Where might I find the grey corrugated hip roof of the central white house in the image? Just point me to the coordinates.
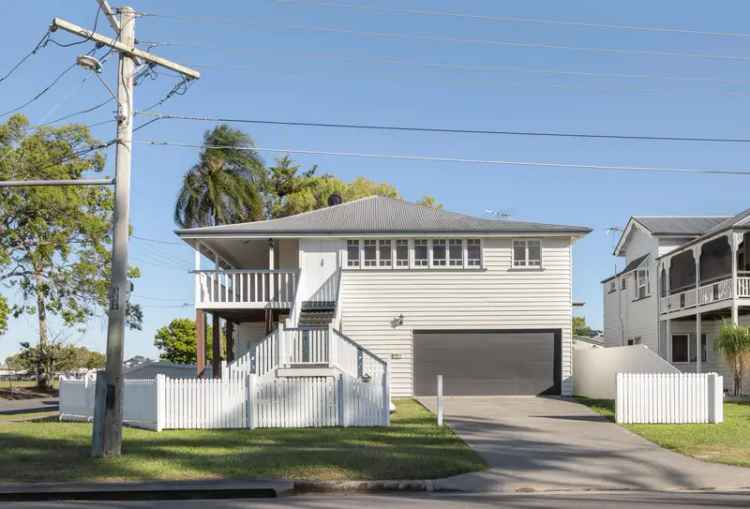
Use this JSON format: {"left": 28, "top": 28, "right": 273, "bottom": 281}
{"left": 176, "top": 196, "right": 591, "bottom": 236}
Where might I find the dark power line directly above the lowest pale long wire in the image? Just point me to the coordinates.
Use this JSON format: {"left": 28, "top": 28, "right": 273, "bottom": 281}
{"left": 136, "top": 111, "right": 750, "bottom": 143}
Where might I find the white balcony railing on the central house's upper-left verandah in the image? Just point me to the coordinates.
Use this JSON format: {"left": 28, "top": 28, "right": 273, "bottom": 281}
{"left": 195, "top": 270, "right": 299, "bottom": 308}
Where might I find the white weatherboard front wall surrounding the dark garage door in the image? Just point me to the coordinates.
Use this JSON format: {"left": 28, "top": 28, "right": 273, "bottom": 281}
{"left": 341, "top": 237, "right": 573, "bottom": 396}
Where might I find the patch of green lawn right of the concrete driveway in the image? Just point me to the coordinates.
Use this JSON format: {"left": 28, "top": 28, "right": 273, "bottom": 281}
{"left": 576, "top": 398, "right": 750, "bottom": 467}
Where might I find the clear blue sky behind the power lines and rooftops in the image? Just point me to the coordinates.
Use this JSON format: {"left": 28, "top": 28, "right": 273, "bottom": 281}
{"left": 0, "top": 0, "right": 750, "bottom": 359}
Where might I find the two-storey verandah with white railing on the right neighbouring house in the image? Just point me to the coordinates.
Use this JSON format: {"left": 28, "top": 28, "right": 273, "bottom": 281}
{"left": 657, "top": 228, "right": 750, "bottom": 372}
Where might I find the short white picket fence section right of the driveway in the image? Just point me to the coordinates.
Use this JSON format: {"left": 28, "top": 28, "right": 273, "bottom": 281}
{"left": 615, "top": 373, "right": 724, "bottom": 424}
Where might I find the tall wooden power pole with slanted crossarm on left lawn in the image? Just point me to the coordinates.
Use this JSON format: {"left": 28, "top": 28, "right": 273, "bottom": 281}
{"left": 51, "top": 4, "right": 200, "bottom": 456}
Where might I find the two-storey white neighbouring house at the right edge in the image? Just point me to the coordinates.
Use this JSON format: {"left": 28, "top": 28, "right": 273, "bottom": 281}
{"left": 602, "top": 209, "right": 750, "bottom": 388}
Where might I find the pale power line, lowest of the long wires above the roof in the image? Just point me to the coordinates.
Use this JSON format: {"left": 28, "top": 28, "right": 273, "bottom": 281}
{"left": 134, "top": 140, "right": 750, "bottom": 177}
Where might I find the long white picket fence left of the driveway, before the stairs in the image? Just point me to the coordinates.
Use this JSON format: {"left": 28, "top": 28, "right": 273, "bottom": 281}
{"left": 60, "top": 370, "right": 390, "bottom": 431}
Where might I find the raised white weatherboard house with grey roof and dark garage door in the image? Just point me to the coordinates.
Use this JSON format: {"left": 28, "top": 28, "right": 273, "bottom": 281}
{"left": 177, "top": 197, "right": 590, "bottom": 396}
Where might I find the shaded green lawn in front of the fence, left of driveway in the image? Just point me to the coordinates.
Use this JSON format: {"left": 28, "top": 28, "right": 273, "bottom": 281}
{"left": 0, "top": 400, "right": 486, "bottom": 482}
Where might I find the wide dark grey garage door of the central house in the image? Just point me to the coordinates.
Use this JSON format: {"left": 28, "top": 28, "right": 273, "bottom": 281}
{"left": 414, "top": 330, "right": 560, "bottom": 396}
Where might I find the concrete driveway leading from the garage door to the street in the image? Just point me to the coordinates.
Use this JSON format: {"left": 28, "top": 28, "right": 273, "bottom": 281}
{"left": 419, "top": 397, "right": 750, "bottom": 492}
